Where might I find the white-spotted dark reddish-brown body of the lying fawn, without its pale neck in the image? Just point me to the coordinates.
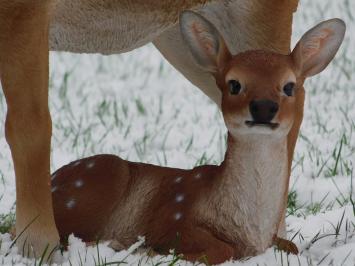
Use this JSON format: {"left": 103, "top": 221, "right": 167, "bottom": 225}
{"left": 52, "top": 149, "right": 286, "bottom": 264}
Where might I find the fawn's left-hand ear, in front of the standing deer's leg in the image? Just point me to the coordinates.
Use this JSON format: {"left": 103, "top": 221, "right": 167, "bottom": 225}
{"left": 180, "top": 11, "right": 231, "bottom": 74}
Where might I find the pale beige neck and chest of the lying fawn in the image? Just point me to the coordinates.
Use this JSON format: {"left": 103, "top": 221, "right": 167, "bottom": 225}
{"left": 206, "top": 135, "right": 288, "bottom": 249}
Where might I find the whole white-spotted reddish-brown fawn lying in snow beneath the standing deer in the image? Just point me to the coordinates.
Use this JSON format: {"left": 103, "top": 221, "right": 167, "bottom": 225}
{"left": 52, "top": 11, "right": 345, "bottom": 263}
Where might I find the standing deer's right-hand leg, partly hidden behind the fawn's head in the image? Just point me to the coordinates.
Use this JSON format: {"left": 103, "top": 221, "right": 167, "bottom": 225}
{"left": 154, "top": 0, "right": 304, "bottom": 240}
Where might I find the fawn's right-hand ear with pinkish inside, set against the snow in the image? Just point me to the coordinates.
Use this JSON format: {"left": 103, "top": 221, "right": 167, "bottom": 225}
{"left": 291, "top": 19, "right": 346, "bottom": 77}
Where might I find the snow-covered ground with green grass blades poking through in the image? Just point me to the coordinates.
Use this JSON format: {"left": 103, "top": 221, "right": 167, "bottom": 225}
{"left": 0, "top": 0, "right": 355, "bottom": 266}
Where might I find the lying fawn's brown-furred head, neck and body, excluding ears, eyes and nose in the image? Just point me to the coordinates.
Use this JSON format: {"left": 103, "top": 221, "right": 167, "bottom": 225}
{"left": 52, "top": 48, "right": 303, "bottom": 263}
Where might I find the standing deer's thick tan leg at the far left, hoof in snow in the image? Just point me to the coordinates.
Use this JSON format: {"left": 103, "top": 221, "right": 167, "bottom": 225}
{"left": 0, "top": 0, "right": 59, "bottom": 256}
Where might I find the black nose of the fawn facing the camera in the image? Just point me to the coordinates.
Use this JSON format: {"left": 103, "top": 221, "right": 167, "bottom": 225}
{"left": 249, "top": 100, "right": 279, "bottom": 123}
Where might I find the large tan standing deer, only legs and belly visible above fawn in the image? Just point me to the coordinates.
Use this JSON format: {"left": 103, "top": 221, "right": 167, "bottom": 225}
{"left": 0, "top": 0, "right": 304, "bottom": 255}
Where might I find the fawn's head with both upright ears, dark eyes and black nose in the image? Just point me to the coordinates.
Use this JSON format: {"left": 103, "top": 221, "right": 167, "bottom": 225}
{"left": 180, "top": 11, "right": 345, "bottom": 136}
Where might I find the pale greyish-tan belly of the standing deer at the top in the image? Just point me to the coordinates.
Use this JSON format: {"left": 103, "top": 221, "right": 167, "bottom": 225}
{"left": 49, "top": 0, "right": 212, "bottom": 54}
